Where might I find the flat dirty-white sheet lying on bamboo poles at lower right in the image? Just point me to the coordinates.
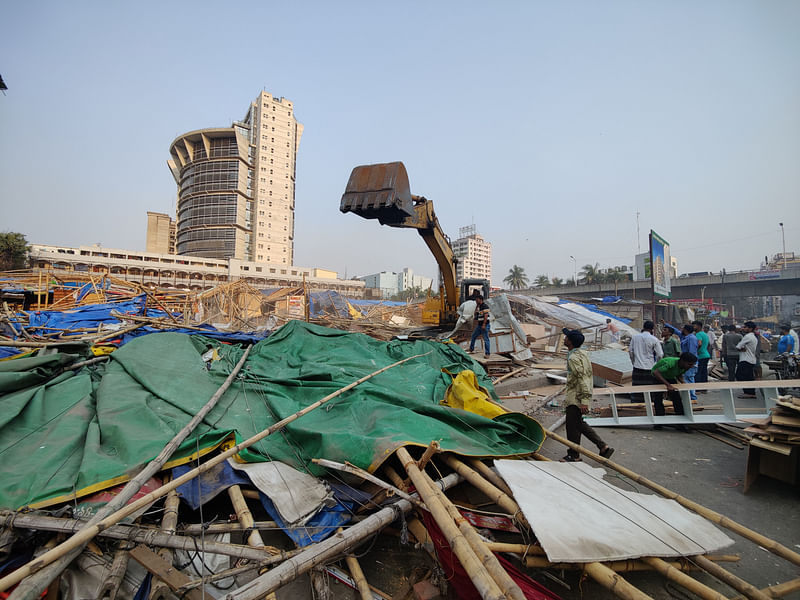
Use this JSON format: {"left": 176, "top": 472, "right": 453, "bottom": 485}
{"left": 494, "top": 460, "right": 733, "bottom": 562}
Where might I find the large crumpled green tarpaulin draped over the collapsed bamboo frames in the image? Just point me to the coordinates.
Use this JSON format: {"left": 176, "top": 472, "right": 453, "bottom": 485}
{"left": 0, "top": 321, "right": 544, "bottom": 509}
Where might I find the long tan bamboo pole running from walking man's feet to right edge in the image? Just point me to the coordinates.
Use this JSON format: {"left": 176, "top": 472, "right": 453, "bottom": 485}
{"left": 547, "top": 432, "right": 800, "bottom": 566}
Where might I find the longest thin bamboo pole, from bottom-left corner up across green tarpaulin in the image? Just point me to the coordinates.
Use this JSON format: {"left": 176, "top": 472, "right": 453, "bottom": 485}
{"left": 0, "top": 349, "right": 430, "bottom": 600}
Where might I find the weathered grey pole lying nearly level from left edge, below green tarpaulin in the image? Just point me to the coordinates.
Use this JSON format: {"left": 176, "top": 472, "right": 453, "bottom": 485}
{"left": 0, "top": 512, "right": 297, "bottom": 564}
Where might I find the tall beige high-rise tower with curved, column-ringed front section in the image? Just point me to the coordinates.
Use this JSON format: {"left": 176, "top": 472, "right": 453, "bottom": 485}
{"left": 167, "top": 92, "right": 303, "bottom": 265}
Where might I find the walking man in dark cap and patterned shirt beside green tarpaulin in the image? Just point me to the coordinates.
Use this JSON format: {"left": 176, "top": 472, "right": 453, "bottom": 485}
{"left": 561, "top": 328, "right": 614, "bottom": 462}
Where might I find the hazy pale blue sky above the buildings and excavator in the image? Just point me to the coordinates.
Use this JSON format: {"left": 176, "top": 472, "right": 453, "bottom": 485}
{"left": 0, "top": 0, "right": 800, "bottom": 285}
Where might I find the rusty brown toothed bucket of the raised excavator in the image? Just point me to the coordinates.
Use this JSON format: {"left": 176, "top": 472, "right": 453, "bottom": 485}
{"left": 339, "top": 162, "right": 414, "bottom": 226}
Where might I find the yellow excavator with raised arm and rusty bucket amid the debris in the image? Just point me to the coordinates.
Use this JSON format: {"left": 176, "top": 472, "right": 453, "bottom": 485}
{"left": 339, "top": 162, "right": 489, "bottom": 327}
